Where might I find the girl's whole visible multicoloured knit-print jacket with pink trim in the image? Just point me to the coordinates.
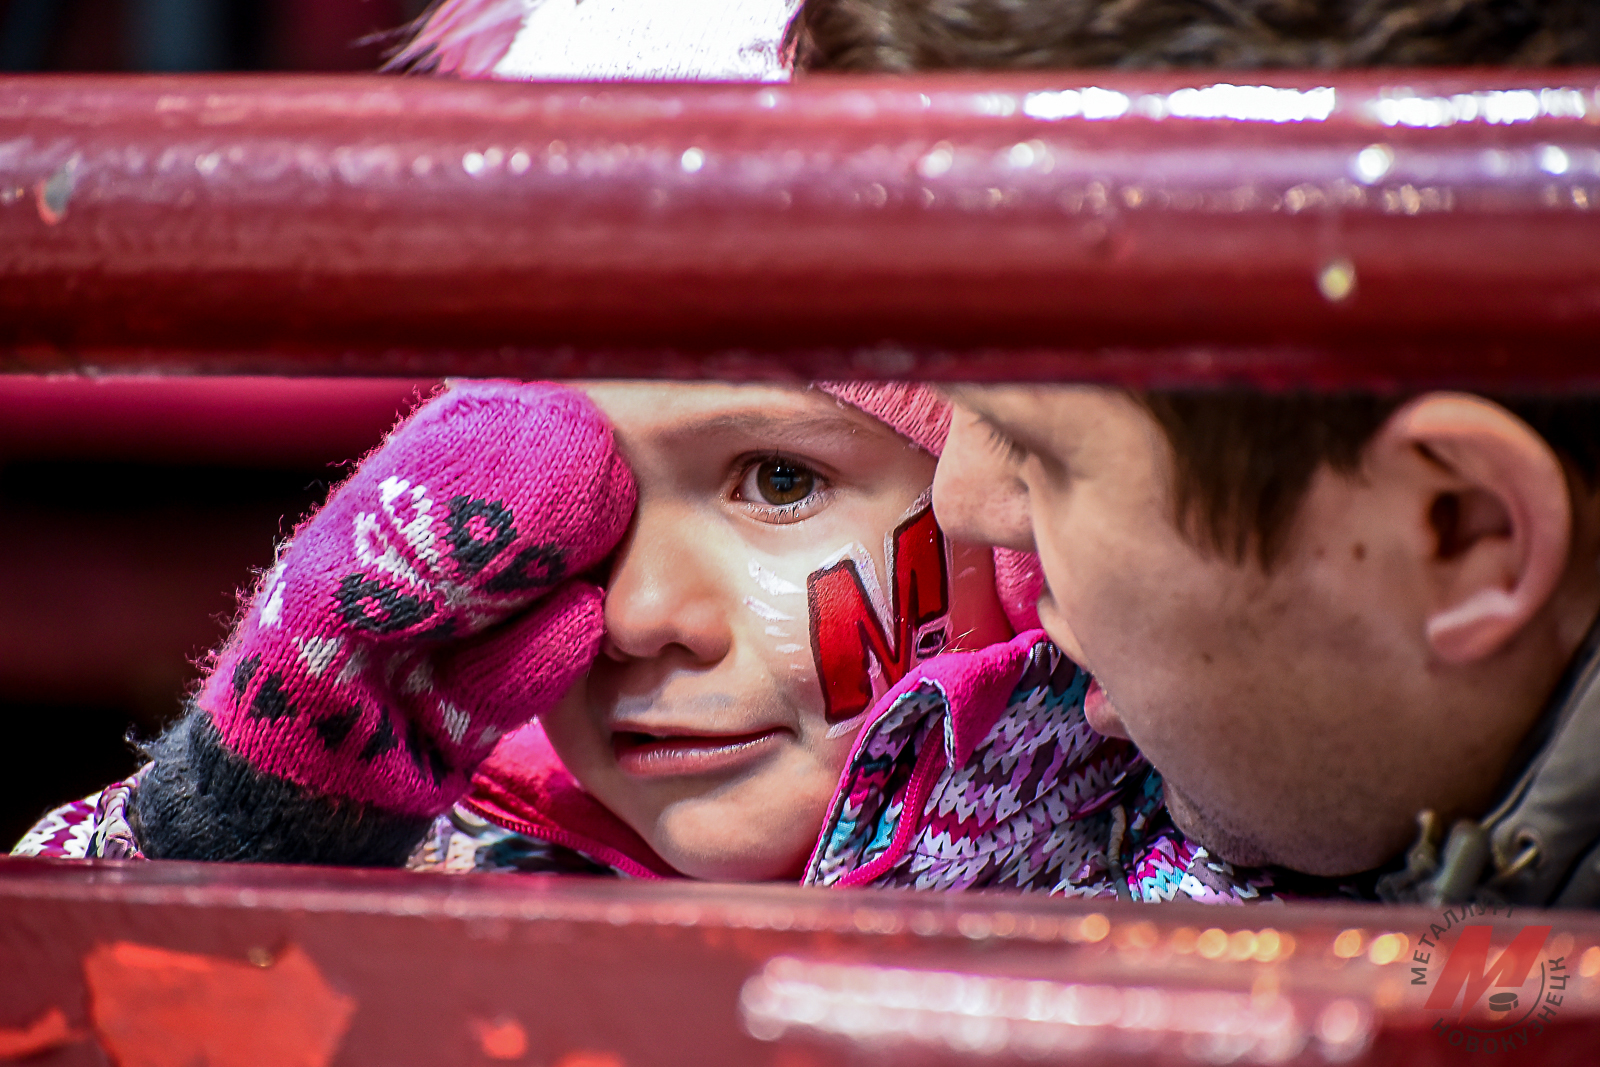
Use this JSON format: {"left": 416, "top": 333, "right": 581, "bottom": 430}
{"left": 16, "top": 630, "right": 1342, "bottom": 904}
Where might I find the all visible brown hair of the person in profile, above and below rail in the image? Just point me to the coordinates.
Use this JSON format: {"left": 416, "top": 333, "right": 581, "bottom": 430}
{"left": 806, "top": 0, "right": 1600, "bottom": 566}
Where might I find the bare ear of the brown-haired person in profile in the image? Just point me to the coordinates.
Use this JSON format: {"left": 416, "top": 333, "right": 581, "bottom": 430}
{"left": 1374, "top": 392, "right": 1573, "bottom": 664}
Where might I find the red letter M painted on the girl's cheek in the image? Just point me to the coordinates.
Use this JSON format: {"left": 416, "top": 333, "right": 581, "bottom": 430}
{"left": 806, "top": 496, "right": 950, "bottom": 723}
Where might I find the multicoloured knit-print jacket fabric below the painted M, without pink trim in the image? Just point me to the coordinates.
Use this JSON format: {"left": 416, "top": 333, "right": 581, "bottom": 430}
{"left": 806, "top": 641, "right": 1299, "bottom": 904}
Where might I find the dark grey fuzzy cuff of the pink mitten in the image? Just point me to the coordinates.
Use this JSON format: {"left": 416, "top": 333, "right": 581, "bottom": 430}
{"left": 130, "top": 707, "right": 434, "bottom": 867}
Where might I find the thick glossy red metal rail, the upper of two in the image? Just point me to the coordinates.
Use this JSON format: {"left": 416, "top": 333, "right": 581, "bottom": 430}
{"left": 0, "top": 70, "right": 1600, "bottom": 387}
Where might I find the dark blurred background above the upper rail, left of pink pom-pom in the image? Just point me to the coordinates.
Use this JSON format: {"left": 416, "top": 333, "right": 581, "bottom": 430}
{"left": 0, "top": 0, "right": 427, "bottom": 72}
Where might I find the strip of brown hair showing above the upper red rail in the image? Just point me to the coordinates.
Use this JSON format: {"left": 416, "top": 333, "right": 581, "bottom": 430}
{"left": 792, "top": 0, "right": 1600, "bottom": 72}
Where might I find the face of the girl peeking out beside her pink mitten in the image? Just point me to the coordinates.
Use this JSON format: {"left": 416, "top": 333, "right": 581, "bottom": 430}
{"left": 544, "top": 382, "right": 1010, "bottom": 881}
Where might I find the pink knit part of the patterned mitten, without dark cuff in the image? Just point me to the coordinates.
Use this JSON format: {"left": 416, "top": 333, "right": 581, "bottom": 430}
{"left": 197, "top": 382, "right": 634, "bottom": 816}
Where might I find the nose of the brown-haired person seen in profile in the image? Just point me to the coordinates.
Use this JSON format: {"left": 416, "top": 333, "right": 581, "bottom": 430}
{"left": 933, "top": 405, "right": 1034, "bottom": 552}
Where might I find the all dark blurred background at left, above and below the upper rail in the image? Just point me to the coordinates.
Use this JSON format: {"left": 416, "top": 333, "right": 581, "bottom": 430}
{"left": 0, "top": 0, "right": 444, "bottom": 853}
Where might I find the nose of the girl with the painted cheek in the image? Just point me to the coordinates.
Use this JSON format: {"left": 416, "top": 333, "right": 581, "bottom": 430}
{"left": 602, "top": 502, "right": 733, "bottom": 664}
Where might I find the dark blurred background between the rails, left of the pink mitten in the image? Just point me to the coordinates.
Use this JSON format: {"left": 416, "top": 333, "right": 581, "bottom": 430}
{"left": 0, "top": 374, "right": 435, "bottom": 851}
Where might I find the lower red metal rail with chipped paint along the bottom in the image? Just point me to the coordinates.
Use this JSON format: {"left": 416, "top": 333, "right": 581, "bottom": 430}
{"left": 0, "top": 859, "right": 1600, "bottom": 1067}
